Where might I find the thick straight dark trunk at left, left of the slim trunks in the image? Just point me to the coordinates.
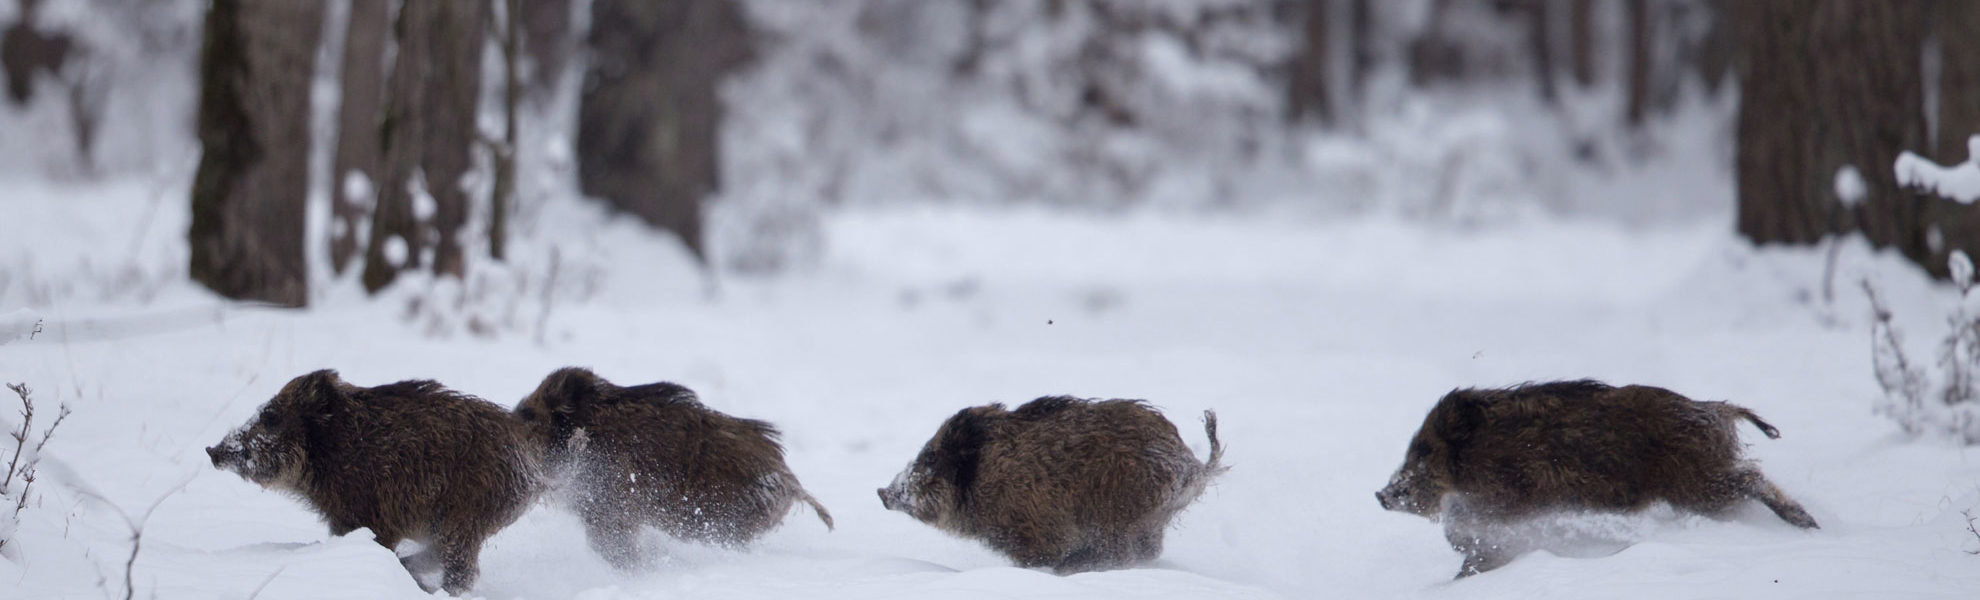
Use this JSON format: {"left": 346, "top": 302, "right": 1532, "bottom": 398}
{"left": 186, "top": 0, "right": 323, "bottom": 307}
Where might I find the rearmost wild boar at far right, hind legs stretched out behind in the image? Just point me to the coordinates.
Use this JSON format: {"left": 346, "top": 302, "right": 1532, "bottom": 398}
{"left": 1376, "top": 380, "right": 1818, "bottom": 576}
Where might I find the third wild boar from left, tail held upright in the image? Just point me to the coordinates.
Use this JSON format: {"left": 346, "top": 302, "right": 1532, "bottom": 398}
{"left": 879, "top": 396, "right": 1228, "bottom": 574}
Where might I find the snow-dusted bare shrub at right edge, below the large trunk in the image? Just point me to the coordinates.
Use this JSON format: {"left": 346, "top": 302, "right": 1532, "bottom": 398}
{"left": 1863, "top": 250, "right": 1980, "bottom": 444}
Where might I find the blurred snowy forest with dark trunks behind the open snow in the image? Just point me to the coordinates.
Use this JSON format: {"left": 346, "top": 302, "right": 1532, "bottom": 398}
{"left": 0, "top": 0, "right": 1980, "bottom": 305}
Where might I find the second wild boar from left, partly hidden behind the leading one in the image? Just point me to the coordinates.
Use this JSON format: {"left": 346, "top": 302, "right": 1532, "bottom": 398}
{"left": 515, "top": 366, "right": 832, "bottom": 568}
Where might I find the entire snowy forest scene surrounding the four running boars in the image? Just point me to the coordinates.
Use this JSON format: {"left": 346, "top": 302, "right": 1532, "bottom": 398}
{"left": 0, "top": 0, "right": 1980, "bottom": 598}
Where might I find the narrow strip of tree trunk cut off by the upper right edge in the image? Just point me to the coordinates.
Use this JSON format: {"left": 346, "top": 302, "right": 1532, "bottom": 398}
{"left": 1934, "top": 2, "right": 1980, "bottom": 164}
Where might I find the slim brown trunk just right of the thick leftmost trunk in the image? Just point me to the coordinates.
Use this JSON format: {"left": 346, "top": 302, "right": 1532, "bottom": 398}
{"left": 329, "top": 0, "right": 392, "bottom": 273}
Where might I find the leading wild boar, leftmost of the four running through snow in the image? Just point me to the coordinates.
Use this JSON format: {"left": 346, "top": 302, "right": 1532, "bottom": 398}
{"left": 206, "top": 370, "right": 543, "bottom": 594}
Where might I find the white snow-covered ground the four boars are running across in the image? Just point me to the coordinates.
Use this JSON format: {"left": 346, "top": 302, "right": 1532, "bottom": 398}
{"left": 0, "top": 180, "right": 1980, "bottom": 600}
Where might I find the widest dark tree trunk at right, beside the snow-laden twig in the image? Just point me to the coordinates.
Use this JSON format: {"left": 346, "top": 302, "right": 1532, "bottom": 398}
{"left": 1733, "top": 0, "right": 1948, "bottom": 277}
